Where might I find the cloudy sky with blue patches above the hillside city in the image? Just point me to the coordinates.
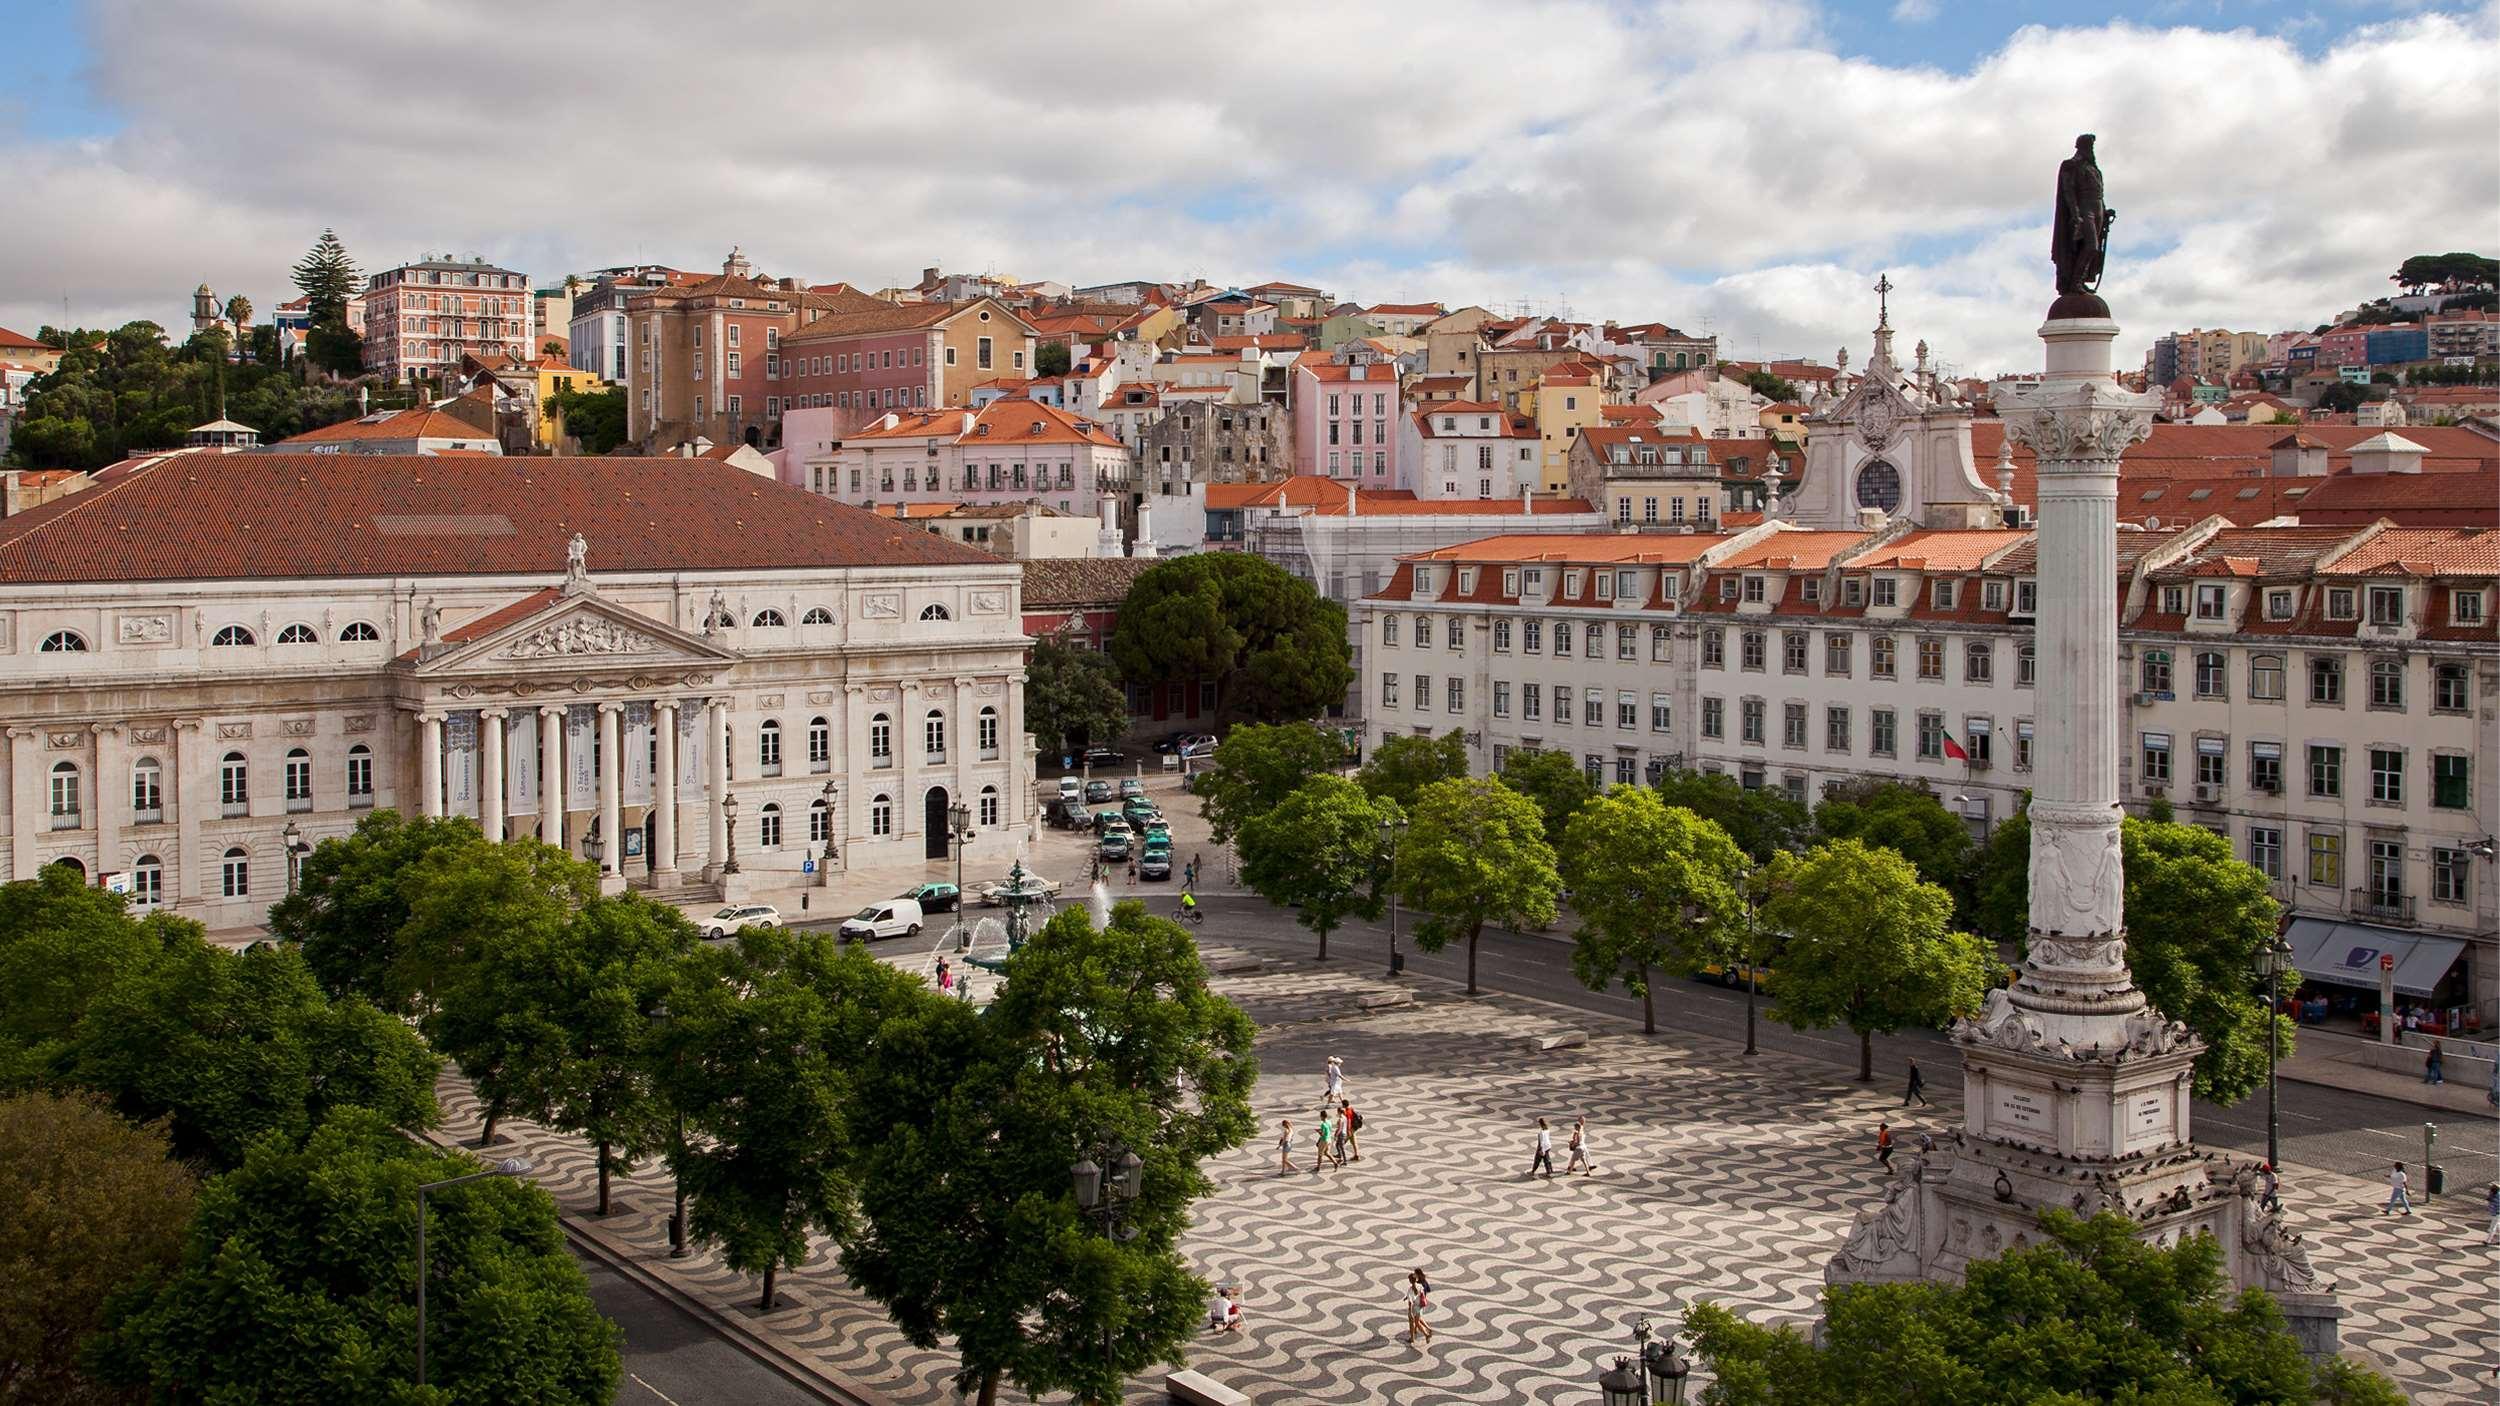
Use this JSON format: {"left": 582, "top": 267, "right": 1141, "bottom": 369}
{"left": 0, "top": 0, "right": 2500, "bottom": 373}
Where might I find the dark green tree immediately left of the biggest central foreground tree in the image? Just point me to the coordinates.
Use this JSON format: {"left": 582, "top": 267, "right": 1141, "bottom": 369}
{"left": 650, "top": 928, "right": 928, "bottom": 1308}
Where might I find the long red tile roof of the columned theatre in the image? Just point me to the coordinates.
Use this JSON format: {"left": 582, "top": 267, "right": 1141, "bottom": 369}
{"left": 0, "top": 453, "right": 998, "bottom": 583}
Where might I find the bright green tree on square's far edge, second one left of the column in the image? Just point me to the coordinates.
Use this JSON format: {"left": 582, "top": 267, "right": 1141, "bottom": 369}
{"left": 1560, "top": 786, "right": 1753, "bottom": 1036}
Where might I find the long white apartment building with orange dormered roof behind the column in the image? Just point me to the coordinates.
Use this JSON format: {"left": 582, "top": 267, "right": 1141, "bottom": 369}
{"left": 1350, "top": 518, "right": 2500, "bottom": 1021}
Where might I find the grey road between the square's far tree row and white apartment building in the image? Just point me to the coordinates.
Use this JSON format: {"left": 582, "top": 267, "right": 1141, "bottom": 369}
{"left": 1148, "top": 888, "right": 2500, "bottom": 1191}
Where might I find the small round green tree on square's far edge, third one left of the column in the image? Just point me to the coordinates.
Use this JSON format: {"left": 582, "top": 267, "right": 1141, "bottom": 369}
{"left": 1398, "top": 776, "right": 1563, "bottom": 996}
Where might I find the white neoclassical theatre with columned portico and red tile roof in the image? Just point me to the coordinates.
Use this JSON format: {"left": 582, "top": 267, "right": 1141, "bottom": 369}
{"left": 0, "top": 453, "right": 1035, "bottom": 928}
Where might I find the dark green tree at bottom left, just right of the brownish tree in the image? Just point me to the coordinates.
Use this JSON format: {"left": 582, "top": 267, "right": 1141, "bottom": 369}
{"left": 93, "top": 1108, "right": 618, "bottom": 1406}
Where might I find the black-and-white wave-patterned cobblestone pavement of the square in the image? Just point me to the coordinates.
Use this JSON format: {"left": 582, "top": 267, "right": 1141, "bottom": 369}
{"left": 443, "top": 948, "right": 2495, "bottom": 1406}
